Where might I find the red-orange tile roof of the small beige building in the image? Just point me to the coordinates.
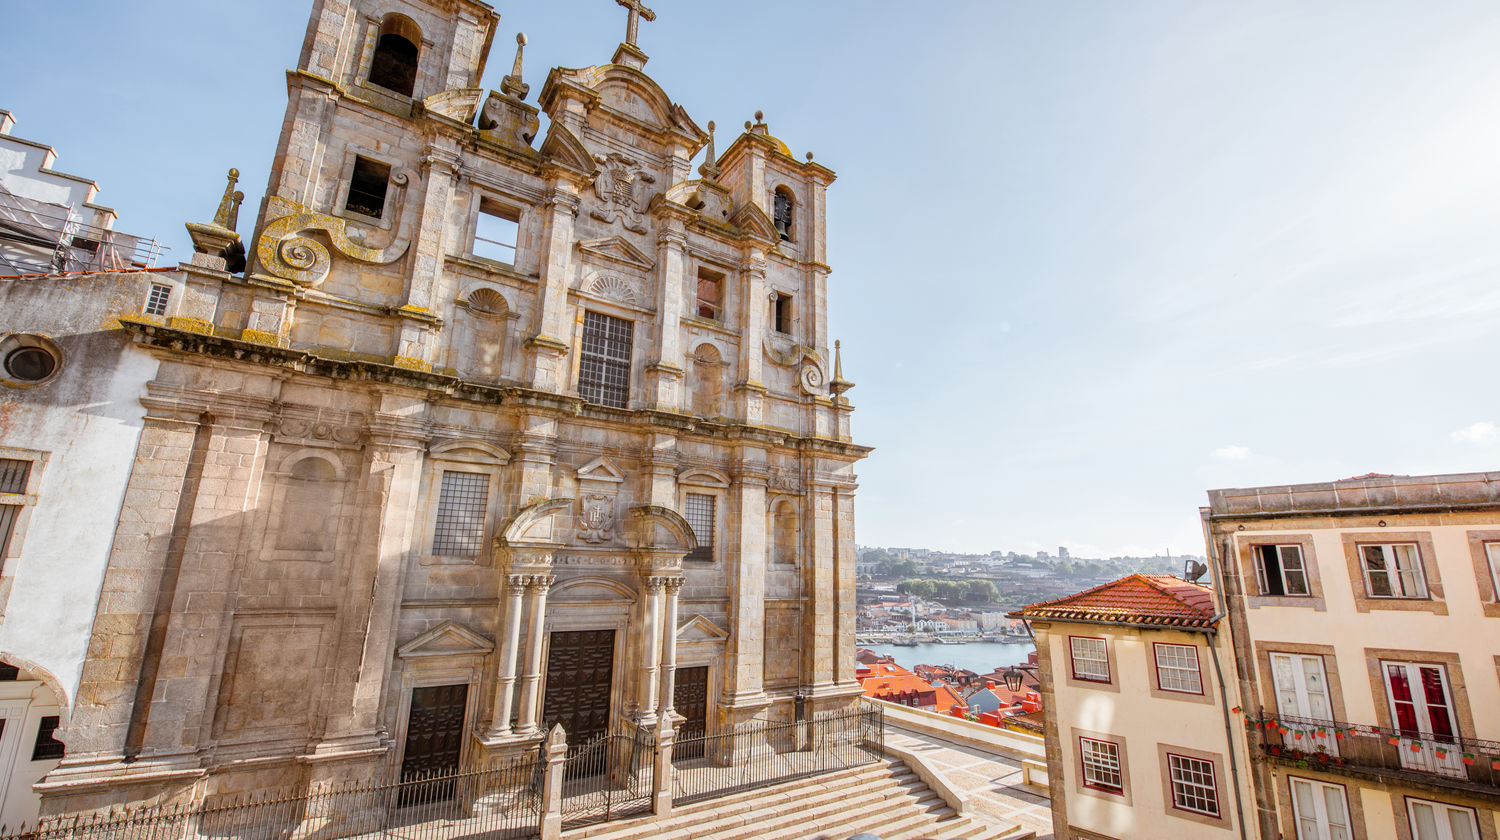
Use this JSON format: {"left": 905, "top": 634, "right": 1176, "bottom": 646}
{"left": 1011, "top": 575, "right": 1215, "bottom": 627}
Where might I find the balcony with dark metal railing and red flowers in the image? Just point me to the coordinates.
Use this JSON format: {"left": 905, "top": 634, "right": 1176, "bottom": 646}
{"left": 1251, "top": 716, "right": 1500, "bottom": 797}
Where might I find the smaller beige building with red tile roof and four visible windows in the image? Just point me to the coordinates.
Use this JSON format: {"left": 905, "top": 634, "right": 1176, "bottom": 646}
{"left": 1013, "top": 575, "right": 1256, "bottom": 840}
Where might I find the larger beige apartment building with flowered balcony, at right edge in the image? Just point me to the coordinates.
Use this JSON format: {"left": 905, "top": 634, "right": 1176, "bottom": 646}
{"left": 1206, "top": 473, "right": 1500, "bottom": 840}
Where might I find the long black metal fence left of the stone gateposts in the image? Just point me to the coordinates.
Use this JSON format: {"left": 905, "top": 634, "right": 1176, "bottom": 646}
{"left": 0, "top": 755, "right": 543, "bottom": 840}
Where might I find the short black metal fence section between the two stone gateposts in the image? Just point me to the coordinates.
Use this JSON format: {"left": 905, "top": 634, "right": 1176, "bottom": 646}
{"left": 563, "top": 731, "right": 657, "bottom": 828}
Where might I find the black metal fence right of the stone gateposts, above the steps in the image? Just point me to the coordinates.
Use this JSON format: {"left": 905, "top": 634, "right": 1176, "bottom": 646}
{"left": 672, "top": 707, "right": 885, "bottom": 804}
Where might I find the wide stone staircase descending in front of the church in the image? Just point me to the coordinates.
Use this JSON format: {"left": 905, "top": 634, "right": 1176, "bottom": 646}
{"left": 563, "top": 761, "right": 1035, "bottom": 840}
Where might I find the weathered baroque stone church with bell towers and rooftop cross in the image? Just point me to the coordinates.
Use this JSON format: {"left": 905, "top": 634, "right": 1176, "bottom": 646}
{"left": 38, "top": 0, "right": 869, "bottom": 813}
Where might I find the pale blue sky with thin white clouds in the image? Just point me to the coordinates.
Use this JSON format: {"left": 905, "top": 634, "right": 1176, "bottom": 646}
{"left": 0, "top": 0, "right": 1500, "bottom": 557}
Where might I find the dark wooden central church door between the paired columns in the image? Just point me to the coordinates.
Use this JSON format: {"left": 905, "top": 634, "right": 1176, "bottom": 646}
{"left": 542, "top": 630, "right": 615, "bottom": 746}
